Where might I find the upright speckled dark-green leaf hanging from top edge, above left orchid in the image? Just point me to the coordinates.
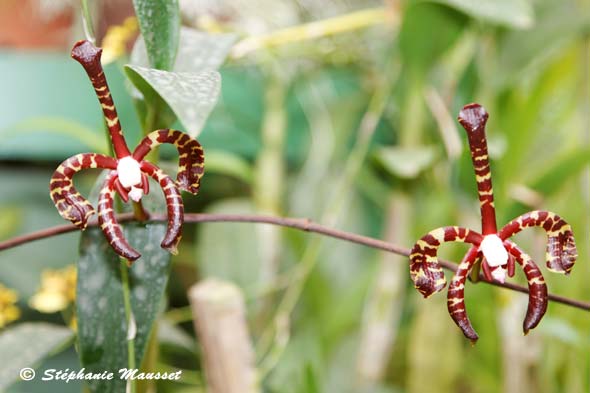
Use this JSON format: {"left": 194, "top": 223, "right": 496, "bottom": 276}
{"left": 133, "top": 0, "right": 180, "bottom": 70}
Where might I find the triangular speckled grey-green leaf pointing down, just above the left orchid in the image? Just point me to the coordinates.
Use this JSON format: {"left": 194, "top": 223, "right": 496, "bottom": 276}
{"left": 125, "top": 65, "right": 221, "bottom": 137}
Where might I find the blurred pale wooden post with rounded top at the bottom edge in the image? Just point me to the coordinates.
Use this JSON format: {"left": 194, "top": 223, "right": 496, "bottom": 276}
{"left": 188, "top": 279, "right": 260, "bottom": 393}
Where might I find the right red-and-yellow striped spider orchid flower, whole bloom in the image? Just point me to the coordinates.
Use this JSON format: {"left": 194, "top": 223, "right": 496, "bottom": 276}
{"left": 410, "top": 104, "right": 577, "bottom": 343}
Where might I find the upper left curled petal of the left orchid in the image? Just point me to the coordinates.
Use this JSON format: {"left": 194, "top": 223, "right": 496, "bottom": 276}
{"left": 49, "top": 153, "right": 117, "bottom": 230}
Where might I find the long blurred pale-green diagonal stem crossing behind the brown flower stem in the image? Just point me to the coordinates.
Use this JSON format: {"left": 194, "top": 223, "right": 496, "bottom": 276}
{"left": 257, "top": 60, "right": 398, "bottom": 378}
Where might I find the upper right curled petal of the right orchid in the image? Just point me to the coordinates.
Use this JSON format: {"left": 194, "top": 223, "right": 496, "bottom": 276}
{"left": 498, "top": 210, "right": 578, "bottom": 274}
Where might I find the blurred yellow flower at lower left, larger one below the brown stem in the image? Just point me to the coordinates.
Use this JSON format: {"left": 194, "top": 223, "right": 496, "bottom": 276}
{"left": 29, "top": 265, "right": 76, "bottom": 313}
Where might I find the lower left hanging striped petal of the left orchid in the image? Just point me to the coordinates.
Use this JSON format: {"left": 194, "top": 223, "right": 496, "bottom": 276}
{"left": 98, "top": 172, "right": 141, "bottom": 264}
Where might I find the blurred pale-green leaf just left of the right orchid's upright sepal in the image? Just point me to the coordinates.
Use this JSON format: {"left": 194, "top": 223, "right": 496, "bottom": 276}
{"left": 375, "top": 146, "right": 436, "bottom": 179}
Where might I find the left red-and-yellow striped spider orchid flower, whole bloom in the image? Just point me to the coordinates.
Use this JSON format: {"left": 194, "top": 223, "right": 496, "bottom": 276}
{"left": 49, "top": 41, "right": 204, "bottom": 264}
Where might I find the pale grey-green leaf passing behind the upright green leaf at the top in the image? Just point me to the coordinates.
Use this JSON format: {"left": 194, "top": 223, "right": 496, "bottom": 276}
{"left": 130, "top": 27, "right": 236, "bottom": 73}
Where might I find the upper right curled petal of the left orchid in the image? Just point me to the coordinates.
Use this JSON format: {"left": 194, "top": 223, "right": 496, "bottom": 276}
{"left": 133, "top": 129, "right": 205, "bottom": 194}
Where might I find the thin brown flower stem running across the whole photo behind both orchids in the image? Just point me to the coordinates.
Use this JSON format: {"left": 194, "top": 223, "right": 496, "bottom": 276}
{"left": 0, "top": 213, "right": 590, "bottom": 311}
